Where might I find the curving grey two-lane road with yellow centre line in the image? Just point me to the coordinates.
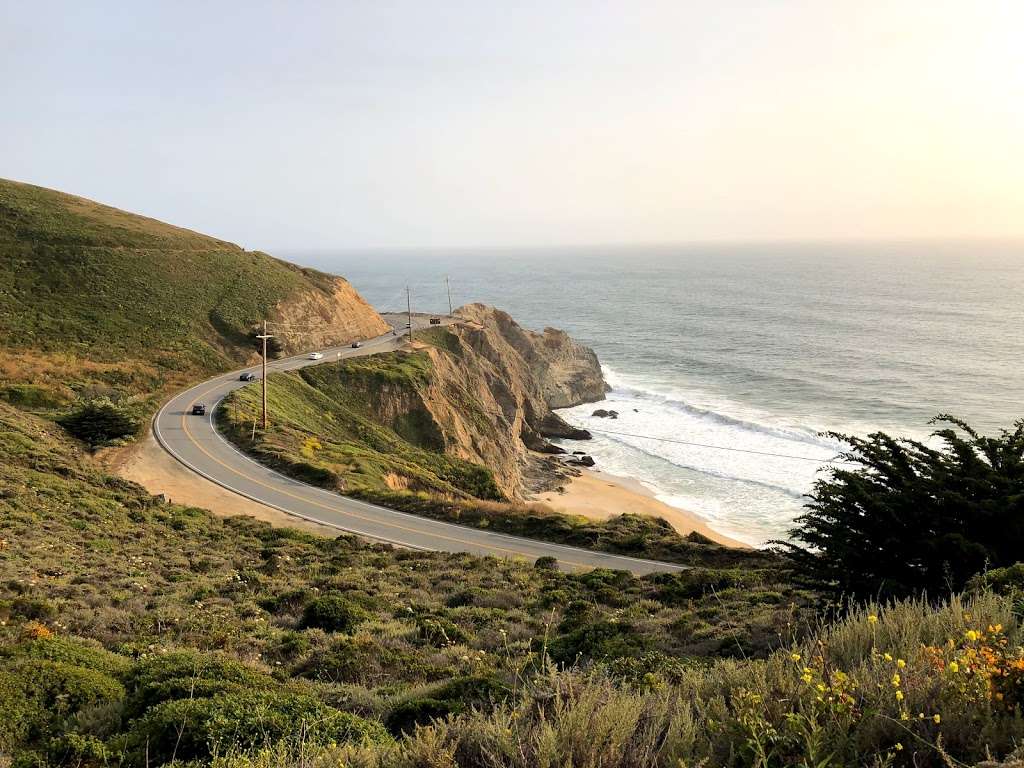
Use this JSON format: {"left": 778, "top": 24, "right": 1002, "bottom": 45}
{"left": 153, "top": 316, "right": 682, "bottom": 573}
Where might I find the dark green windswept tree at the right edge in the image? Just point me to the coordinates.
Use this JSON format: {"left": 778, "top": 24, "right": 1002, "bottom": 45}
{"left": 777, "top": 416, "right": 1024, "bottom": 598}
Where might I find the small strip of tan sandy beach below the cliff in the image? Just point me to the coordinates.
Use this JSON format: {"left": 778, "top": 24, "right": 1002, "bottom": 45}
{"left": 536, "top": 469, "right": 748, "bottom": 547}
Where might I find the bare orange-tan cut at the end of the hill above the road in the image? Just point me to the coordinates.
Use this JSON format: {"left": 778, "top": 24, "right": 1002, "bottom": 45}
{"left": 270, "top": 278, "right": 390, "bottom": 354}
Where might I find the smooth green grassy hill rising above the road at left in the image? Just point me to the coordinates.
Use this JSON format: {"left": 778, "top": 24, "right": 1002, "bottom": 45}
{"left": 0, "top": 179, "right": 360, "bottom": 421}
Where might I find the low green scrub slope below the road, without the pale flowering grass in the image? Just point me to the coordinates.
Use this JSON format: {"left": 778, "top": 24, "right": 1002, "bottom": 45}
{"left": 0, "top": 404, "right": 805, "bottom": 765}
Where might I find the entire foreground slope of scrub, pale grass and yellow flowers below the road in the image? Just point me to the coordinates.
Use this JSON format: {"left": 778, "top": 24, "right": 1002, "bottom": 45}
{"left": 0, "top": 406, "right": 1024, "bottom": 768}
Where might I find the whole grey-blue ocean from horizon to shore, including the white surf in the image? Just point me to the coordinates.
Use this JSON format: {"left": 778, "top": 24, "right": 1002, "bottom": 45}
{"left": 283, "top": 242, "right": 1024, "bottom": 545}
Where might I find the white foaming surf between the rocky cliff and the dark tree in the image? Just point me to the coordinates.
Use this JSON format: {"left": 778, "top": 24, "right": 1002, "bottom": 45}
{"left": 560, "top": 367, "right": 843, "bottom": 544}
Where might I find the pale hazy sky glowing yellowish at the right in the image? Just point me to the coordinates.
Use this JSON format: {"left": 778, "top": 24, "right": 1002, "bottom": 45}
{"left": 0, "top": 0, "right": 1024, "bottom": 251}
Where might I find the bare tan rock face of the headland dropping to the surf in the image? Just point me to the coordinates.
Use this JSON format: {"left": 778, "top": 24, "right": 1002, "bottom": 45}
{"left": 347, "top": 304, "right": 606, "bottom": 499}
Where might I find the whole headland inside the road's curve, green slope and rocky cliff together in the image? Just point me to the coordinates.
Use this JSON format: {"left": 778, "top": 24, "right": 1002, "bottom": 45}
{"left": 225, "top": 304, "right": 605, "bottom": 501}
